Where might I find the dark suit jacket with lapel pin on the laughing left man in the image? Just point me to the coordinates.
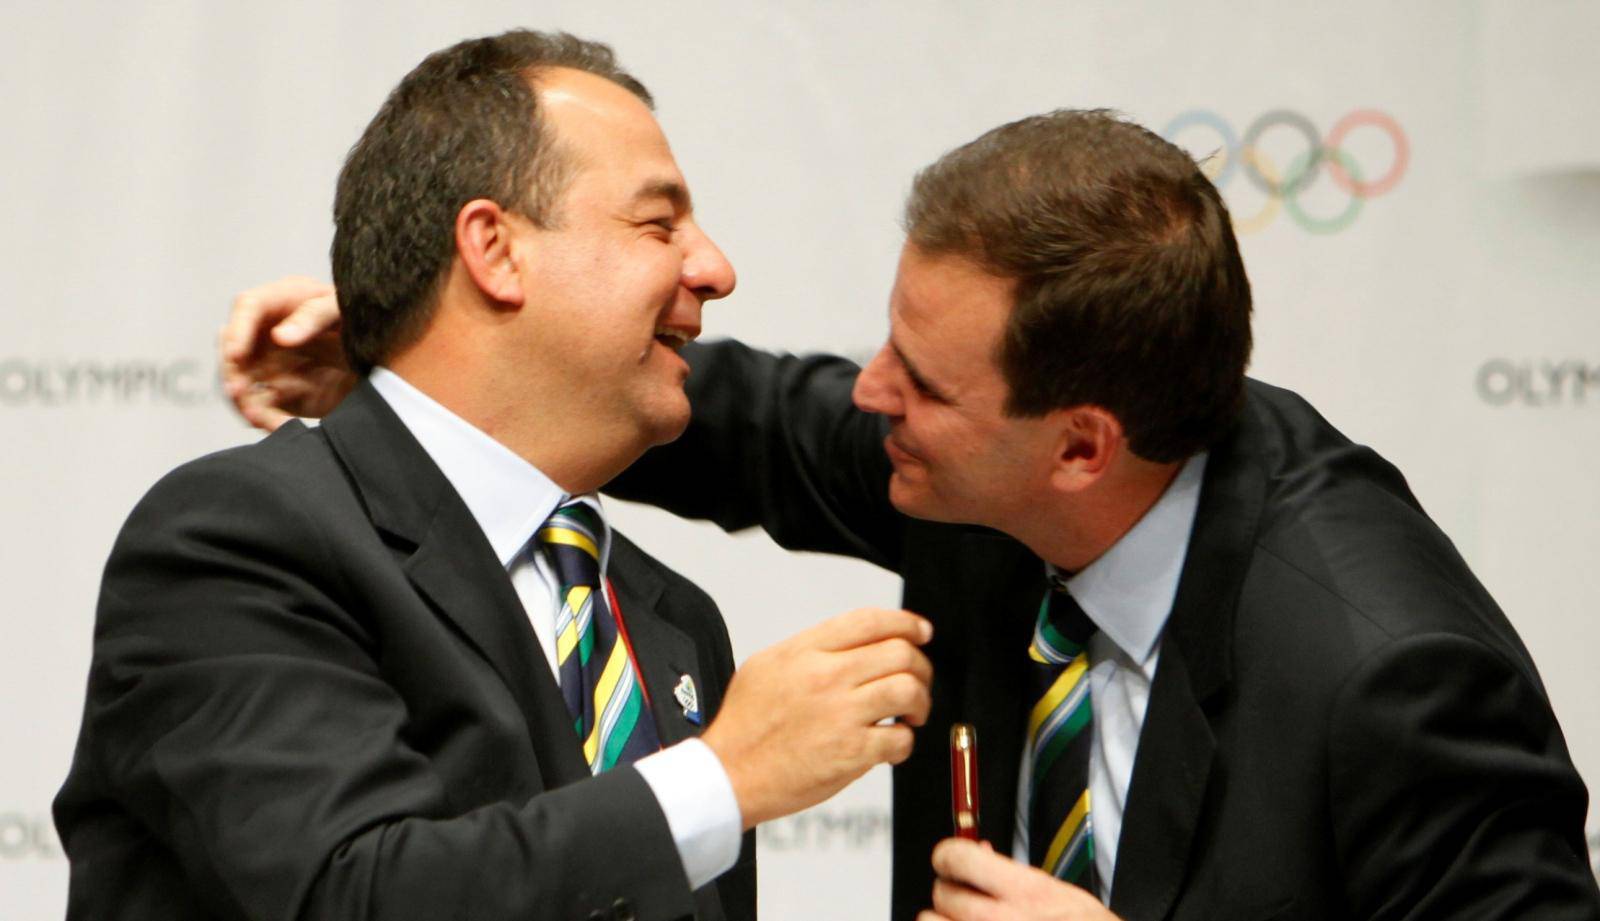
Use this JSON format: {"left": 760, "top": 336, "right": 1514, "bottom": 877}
{"left": 56, "top": 384, "right": 755, "bottom": 921}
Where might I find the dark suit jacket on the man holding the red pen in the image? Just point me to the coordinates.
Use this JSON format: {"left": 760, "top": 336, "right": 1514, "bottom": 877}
{"left": 613, "top": 344, "right": 1600, "bottom": 921}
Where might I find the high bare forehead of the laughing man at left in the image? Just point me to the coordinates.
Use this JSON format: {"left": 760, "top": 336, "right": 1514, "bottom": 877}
{"left": 534, "top": 67, "right": 683, "bottom": 187}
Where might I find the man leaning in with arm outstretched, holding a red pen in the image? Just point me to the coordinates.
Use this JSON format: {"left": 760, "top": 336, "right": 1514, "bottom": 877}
{"left": 216, "top": 112, "right": 1600, "bottom": 921}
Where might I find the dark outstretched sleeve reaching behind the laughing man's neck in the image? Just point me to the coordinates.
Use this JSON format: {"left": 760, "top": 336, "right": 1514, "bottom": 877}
{"left": 606, "top": 341, "right": 906, "bottom": 571}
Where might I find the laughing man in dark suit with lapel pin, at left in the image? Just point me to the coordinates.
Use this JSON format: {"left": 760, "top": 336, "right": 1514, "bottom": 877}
{"left": 56, "top": 32, "right": 928, "bottom": 921}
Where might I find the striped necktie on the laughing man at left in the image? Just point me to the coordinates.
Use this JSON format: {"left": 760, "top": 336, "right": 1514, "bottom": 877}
{"left": 536, "top": 499, "right": 661, "bottom": 774}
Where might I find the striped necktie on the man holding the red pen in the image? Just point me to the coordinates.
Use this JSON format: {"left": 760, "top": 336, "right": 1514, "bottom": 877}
{"left": 1027, "top": 588, "right": 1099, "bottom": 897}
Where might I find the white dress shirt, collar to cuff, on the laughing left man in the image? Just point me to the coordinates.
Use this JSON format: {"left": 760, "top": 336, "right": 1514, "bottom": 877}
{"left": 371, "top": 368, "right": 741, "bottom": 889}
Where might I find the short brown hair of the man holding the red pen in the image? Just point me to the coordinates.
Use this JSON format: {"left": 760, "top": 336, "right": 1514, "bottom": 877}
{"left": 906, "top": 109, "right": 1251, "bottom": 462}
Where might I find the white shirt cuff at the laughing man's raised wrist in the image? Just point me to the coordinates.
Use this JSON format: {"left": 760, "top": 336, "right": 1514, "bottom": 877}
{"left": 634, "top": 739, "right": 742, "bottom": 889}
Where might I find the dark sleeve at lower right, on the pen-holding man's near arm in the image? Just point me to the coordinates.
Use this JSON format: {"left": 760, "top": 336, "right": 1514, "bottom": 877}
{"left": 1330, "top": 635, "right": 1600, "bottom": 921}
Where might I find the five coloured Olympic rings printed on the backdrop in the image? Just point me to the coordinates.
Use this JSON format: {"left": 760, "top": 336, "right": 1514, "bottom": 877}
{"left": 1162, "top": 109, "right": 1411, "bottom": 233}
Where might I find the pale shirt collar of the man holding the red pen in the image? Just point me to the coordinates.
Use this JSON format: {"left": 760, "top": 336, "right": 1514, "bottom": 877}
{"left": 1045, "top": 451, "right": 1206, "bottom": 662}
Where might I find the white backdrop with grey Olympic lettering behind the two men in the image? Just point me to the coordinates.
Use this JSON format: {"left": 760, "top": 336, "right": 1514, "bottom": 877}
{"left": 0, "top": 0, "right": 1600, "bottom": 919}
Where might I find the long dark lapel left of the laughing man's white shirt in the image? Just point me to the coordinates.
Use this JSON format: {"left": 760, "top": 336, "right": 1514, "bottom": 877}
{"left": 323, "top": 381, "right": 589, "bottom": 787}
